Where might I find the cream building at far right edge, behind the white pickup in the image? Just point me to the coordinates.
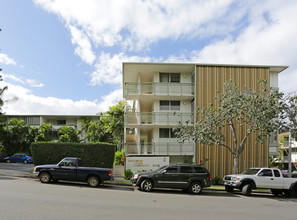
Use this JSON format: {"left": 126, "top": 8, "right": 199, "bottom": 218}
{"left": 279, "top": 132, "right": 297, "bottom": 170}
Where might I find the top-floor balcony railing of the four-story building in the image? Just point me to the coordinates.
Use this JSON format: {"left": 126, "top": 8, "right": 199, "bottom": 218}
{"left": 124, "top": 82, "right": 194, "bottom": 97}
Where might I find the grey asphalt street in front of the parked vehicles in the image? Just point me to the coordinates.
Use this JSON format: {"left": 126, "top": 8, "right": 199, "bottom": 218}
{"left": 0, "top": 176, "right": 297, "bottom": 220}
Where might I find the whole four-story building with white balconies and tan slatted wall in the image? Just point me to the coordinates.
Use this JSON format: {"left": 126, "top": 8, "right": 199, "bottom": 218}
{"left": 123, "top": 63, "right": 287, "bottom": 177}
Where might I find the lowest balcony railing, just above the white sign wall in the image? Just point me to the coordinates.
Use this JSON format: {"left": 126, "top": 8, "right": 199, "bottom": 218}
{"left": 125, "top": 142, "right": 195, "bottom": 155}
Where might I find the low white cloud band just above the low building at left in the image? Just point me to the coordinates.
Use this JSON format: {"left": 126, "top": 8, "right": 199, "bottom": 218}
{"left": 0, "top": 82, "right": 123, "bottom": 115}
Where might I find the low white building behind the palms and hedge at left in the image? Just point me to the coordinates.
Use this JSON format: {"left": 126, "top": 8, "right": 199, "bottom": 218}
{"left": 6, "top": 115, "right": 100, "bottom": 141}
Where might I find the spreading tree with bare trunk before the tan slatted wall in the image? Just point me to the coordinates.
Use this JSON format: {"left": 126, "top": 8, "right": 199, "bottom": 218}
{"left": 175, "top": 81, "right": 283, "bottom": 174}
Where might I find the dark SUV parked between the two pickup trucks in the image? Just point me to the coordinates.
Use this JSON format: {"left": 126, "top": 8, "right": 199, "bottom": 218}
{"left": 131, "top": 164, "right": 211, "bottom": 194}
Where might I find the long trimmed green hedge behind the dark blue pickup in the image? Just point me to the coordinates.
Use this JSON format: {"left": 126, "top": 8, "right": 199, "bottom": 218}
{"left": 31, "top": 142, "right": 116, "bottom": 168}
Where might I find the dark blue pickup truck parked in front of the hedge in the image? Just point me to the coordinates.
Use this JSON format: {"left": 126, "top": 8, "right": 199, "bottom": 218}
{"left": 33, "top": 157, "right": 113, "bottom": 187}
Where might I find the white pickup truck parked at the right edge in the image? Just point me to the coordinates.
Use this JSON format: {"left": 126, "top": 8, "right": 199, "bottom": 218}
{"left": 223, "top": 168, "right": 297, "bottom": 196}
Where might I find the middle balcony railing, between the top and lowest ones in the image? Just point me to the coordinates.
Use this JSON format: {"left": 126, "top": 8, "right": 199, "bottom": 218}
{"left": 125, "top": 112, "right": 194, "bottom": 125}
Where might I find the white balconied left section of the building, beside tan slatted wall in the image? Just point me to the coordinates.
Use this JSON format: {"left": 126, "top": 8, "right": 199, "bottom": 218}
{"left": 123, "top": 63, "right": 195, "bottom": 170}
